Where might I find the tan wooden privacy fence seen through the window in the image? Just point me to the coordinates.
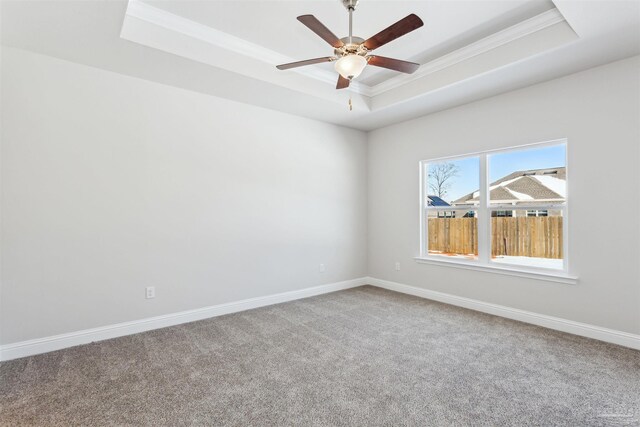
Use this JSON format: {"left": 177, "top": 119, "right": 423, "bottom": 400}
{"left": 428, "top": 216, "right": 562, "bottom": 258}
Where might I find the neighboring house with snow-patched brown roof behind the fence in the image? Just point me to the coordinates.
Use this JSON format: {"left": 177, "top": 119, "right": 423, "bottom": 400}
{"left": 451, "top": 167, "right": 567, "bottom": 217}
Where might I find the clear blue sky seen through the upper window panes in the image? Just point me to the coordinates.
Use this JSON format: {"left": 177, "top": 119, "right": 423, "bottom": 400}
{"left": 429, "top": 145, "right": 566, "bottom": 202}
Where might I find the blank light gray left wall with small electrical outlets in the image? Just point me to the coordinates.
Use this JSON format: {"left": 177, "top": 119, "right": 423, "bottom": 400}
{"left": 0, "top": 48, "right": 367, "bottom": 344}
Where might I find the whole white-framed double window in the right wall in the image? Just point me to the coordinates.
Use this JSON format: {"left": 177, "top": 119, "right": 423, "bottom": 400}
{"left": 420, "top": 140, "right": 567, "bottom": 274}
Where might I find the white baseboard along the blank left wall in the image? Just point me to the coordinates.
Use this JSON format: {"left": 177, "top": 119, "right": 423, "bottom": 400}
{"left": 0, "top": 278, "right": 365, "bottom": 361}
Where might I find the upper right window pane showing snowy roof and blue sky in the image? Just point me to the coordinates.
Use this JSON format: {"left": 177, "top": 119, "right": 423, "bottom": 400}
{"left": 489, "top": 144, "right": 567, "bottom": 207}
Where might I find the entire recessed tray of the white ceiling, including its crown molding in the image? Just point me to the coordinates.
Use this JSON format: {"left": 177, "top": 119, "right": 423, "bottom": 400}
{"left": 121, "top": 0, "right": 576, "bottom": 109}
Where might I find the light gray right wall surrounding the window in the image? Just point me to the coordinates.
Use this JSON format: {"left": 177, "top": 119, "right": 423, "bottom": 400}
{"left": 368, "top": 57, "right": 640, "bottom": 334}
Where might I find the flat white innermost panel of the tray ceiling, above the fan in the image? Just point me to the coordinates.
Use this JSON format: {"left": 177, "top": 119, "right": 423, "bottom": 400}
{"left": 143, "top": 0, "right": 554, "bottom": 85}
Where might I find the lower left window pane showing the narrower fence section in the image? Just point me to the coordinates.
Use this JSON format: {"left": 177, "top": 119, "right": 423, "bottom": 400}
{"left": 427, "top": 210, "right": 478, "bottom": 259}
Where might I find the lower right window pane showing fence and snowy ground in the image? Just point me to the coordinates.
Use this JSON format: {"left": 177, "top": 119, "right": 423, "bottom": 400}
{"left": 491, "top": 209, "right": 563, "bottom": 270}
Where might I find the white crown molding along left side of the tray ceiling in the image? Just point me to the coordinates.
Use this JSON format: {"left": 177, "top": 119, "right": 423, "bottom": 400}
{"left": 126, "top": 0, "right": 370, "bottom": 96}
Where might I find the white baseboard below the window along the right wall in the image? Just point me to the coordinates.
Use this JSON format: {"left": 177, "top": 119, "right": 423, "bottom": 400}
{"left": 365, "top": 277, "right": 640, "bottom": 350}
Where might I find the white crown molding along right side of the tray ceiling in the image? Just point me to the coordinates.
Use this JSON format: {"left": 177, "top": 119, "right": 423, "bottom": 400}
{"left": 370, "top": 8, "right": 565, "bottom": 96}
